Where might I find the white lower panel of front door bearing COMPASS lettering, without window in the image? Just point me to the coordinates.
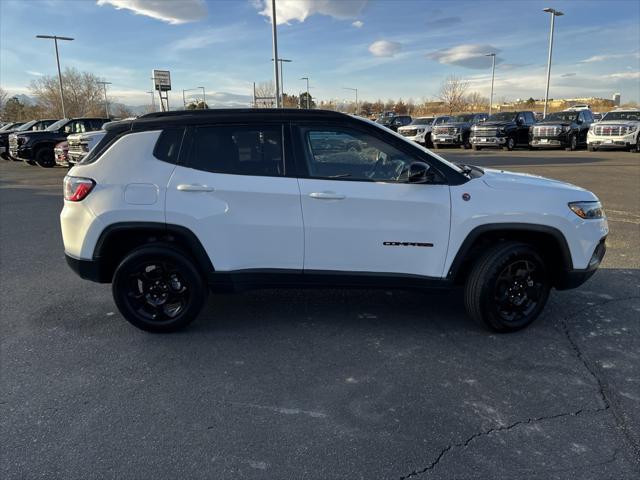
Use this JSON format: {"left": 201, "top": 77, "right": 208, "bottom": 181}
{"left": 299, "top": 179, "right": 450, "bottom": 277}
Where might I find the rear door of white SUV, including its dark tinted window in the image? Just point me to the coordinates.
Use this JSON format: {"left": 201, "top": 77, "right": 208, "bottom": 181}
{"left": 166, "top": 124, "right": 304, "bottom": 271}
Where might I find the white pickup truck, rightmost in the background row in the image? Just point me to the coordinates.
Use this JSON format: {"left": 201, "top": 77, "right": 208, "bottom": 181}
{"left": 587, "top": 108, "right": 640, "bottom": 152}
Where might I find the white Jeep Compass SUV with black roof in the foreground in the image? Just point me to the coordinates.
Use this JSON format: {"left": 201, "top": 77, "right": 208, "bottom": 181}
{"left": 60, "top": 109, "right": 608, "bottom": 332}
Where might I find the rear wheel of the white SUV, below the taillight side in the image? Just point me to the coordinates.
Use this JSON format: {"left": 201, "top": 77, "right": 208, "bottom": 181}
{"left": 111, "top": 245, "right": 208, "bottom": 333}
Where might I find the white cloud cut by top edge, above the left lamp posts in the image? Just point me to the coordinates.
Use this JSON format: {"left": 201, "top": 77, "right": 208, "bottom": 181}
{"left": 97, "top": 0, "right": 207, "bottom": 25}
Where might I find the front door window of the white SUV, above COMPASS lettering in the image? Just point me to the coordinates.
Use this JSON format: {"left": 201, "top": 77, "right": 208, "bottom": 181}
{"left": 302, "top": 128, "right": 415, "bottom": 182}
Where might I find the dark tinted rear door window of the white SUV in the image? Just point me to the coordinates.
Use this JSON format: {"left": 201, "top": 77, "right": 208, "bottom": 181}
{"left": 189, "top": 125, "right": 284, "bottom": 176}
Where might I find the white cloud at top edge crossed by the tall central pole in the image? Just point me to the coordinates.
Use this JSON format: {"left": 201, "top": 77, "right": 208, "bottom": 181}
{"left": 253, "top": 0, "right": 367, "bottom": 25}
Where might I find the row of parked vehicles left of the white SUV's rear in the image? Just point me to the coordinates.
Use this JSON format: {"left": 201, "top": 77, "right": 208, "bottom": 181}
{"left": 0, "top": 117, "right": 111, "bottom": 167}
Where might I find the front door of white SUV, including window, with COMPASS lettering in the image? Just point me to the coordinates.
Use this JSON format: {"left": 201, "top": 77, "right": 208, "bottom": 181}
{"left": 296, "top": 126, "right": 450, "bottom": 277}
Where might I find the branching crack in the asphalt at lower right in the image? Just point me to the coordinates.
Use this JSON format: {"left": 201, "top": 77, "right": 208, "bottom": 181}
{"left": 399, "top": 296, "right": 640, "bottom": 480}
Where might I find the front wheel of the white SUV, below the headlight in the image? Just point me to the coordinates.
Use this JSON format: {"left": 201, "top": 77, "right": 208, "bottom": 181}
{"left": 464, "top": 242, "right": 551, "bottom": 333}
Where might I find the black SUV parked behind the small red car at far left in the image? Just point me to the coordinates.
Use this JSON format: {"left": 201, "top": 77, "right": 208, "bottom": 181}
{"left": 9, "top": 117, "right": 110, "bottom": 167}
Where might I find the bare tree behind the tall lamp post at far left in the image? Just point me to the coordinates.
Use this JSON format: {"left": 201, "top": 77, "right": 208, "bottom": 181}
{"left": 31, "top": 68, "right": 104, "bottom": 118}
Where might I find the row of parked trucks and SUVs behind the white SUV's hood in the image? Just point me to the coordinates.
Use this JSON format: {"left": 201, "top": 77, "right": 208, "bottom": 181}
{"left": 376, "top": 107, "right": 640, "bottom": 152}
